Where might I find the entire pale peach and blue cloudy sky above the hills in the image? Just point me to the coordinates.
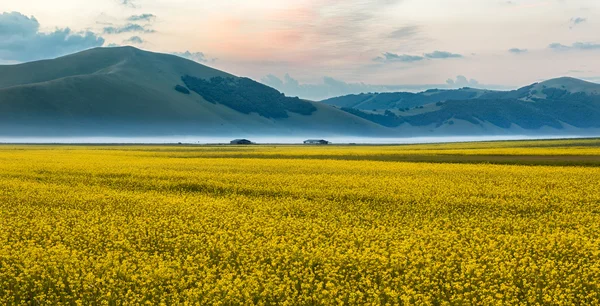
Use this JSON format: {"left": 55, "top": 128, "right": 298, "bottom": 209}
{"left": 0, "top": 0, "right": 600, "bottom": 99}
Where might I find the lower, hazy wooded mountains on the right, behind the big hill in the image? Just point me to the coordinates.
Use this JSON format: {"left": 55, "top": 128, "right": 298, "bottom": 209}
{"left": 323, "top": 77, "right": 600, "bottom": 134}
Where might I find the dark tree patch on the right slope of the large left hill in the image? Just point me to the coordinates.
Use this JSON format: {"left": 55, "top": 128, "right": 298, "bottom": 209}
{"left": 181, "top": 75, "right": 317, "bottom": 119}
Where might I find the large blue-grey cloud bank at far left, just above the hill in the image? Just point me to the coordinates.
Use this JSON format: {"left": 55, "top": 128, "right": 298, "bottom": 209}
{"left": 0, "top": 12, "right": 104, "bottom": 62}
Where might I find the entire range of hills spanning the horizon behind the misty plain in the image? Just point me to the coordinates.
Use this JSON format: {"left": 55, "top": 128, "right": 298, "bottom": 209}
{"left": 0, "top": 47, "right": 600, "bottom": 137}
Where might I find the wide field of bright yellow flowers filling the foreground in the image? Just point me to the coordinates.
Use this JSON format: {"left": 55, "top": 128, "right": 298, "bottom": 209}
{"left": 0, "top": 140, "right": 600, "bottom": 305}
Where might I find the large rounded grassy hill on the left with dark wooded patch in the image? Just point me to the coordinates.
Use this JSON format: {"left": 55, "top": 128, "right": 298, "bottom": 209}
{"left": 0, "top": 47, "right": 388, "bottom": 136}
